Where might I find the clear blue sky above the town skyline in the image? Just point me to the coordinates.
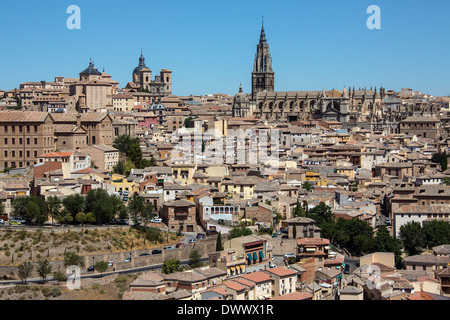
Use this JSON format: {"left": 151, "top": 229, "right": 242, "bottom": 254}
{"left": 0, "top": 0, "right": 450, "bottom": 95}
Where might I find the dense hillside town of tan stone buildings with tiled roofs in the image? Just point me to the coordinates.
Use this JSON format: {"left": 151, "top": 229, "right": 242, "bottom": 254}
{"left": 0, "top": 22, "right": 450, "bottom": 301}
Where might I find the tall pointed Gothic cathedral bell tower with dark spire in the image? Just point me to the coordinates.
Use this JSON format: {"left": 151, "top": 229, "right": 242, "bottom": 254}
{"left": 252, "top": 21, "right": 275, "bottom": 101}
